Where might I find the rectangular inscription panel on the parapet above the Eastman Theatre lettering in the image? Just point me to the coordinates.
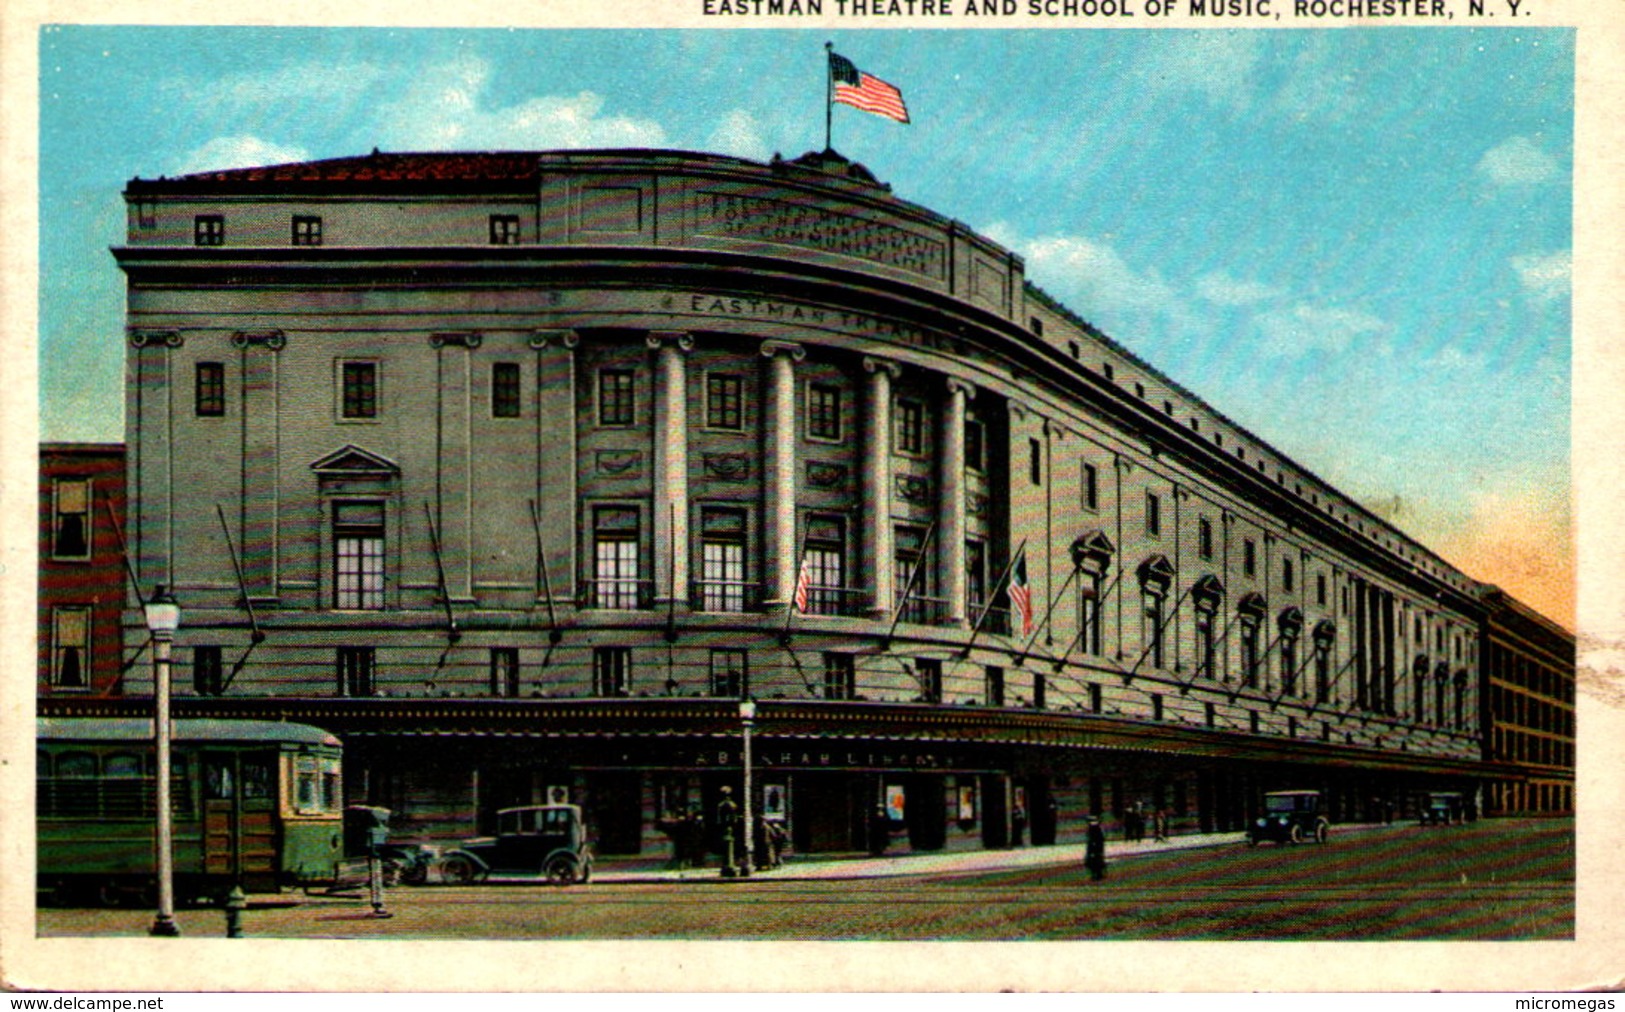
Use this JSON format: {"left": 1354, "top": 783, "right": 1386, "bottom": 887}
{"left": 697, "top": 192, "right": 947, "bottom": 281}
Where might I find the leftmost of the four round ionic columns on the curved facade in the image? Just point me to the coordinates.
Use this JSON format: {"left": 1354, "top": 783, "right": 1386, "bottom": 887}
{"left": 648, "top": 330, "right": 694, "bottom": 604}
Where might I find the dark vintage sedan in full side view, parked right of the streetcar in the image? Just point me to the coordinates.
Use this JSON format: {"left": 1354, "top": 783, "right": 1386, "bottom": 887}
{"left": 440, "top": 804, "right": 593, "bottom": 885}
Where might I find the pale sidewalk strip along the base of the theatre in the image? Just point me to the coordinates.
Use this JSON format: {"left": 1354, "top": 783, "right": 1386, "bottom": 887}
{"left": 593, "top": 824, "right": 1274, "bottom": 882}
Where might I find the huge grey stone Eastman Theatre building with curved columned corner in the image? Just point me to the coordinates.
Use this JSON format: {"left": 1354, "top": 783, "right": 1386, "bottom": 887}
{"left": 47, "top": 151, "right": 1547, "bottom": 854}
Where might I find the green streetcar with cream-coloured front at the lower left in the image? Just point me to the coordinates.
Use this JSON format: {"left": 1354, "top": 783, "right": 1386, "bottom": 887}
{"left": 34, "top": 718, "right": 345, "bottom": 905}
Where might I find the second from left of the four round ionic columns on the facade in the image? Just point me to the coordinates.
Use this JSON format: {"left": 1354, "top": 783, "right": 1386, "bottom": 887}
{"left": 762, "top": 341, "right": 806, "bottom": 606}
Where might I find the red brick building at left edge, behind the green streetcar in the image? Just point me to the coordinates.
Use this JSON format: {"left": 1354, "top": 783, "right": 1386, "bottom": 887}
{"left": 37, "top": 443, "right": 125, "bottom": 697}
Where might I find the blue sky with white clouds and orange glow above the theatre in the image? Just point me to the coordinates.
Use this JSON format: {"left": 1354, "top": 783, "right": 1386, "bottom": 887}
{"left": 39, "top": 26, "right": 1575, "bottom": 622}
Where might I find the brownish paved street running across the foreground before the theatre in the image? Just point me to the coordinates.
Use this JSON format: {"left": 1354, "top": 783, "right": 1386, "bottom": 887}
{"left": 39, "top": 819, "right": 1575, "bottom": 941}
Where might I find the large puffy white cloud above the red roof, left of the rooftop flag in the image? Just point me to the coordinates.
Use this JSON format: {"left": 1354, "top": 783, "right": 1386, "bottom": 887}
{"left": 375, "top": 57, "right": 666, "bottom": 149}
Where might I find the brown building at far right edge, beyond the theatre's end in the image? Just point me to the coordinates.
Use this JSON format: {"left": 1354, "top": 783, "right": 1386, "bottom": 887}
{"left": 1480, "top": 586, "right": 1575, "bottom": 815}
